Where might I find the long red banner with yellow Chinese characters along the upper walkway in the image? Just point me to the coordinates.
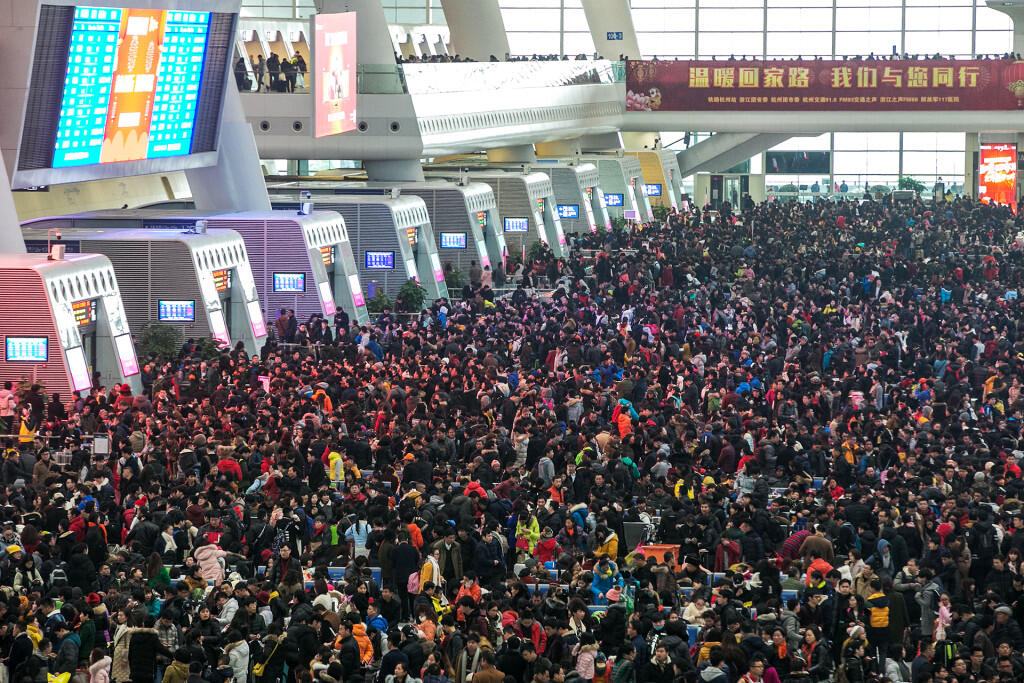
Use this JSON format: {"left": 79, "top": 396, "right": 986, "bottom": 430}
{"left": 626, "top": 59, "right": 1024, "bottom": 112}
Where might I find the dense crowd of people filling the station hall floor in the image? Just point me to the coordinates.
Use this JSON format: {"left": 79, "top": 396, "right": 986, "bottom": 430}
{"left": 0, "top": 192, "right": 1024, "bottom": 683}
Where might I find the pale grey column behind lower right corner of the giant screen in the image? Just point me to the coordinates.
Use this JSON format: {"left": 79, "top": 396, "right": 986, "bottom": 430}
{"left": 185, "top": 88, "right": 270, "bottom": 211}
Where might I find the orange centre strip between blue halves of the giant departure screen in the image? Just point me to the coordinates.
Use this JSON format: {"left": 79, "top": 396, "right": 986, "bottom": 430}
{"left": 99, "top": 9, "right": 167, "bottom": 163}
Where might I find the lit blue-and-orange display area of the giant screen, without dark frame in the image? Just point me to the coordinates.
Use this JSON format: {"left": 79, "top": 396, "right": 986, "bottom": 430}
{"left": 53, "top": 7, "right": 211, "bottom": 168}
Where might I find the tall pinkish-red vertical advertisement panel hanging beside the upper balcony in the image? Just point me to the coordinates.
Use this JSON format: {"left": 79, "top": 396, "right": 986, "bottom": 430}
{"left": 313, "top": 12, "right": 356, "bottom": 137}
